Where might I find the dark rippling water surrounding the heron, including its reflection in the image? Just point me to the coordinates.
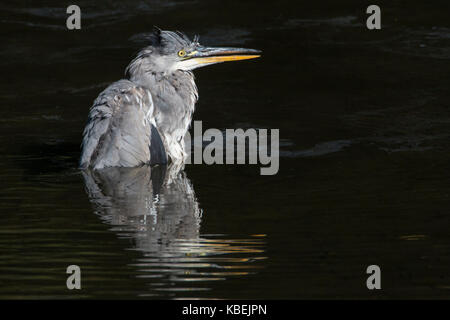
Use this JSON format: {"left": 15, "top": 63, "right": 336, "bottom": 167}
{"left": 0, "top": 0, "right": 450, "bottom": 299}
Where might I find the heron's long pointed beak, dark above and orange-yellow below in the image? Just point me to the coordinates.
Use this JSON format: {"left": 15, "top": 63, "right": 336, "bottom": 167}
{"left": 187, "top": 47, "right": 261, "bottom": 68}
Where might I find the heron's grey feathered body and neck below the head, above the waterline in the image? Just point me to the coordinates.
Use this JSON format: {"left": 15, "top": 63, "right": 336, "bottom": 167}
{"left": 80, "top": 71, "right": 197, "bottom": 169}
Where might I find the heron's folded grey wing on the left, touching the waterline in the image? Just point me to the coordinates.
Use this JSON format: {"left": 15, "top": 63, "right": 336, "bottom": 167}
{"left": 80, "top": 80, "right": 167, "bottom": 169}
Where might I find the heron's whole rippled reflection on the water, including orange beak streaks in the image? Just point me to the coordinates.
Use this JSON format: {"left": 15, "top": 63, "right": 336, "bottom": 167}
{"left": 83, "top": 166, "right": 264, "bottom": 294}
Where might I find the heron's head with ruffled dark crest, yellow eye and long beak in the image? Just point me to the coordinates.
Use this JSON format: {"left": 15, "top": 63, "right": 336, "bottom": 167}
{"left": 127, "top": 29, "right": 261, "bottom": 73}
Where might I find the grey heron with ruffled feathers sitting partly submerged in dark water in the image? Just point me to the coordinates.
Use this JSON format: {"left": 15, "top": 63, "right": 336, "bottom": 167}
{"left": 79, "top": 28, "right": 261, "bottom": 170}
